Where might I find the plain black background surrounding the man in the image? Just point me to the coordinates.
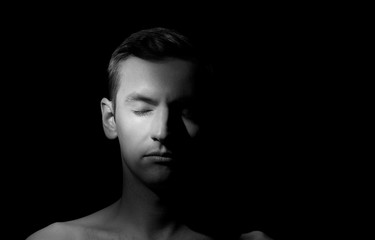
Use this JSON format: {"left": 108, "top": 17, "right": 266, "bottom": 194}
{"left": 2, "top": 4, "right": 368, "bottom": 239}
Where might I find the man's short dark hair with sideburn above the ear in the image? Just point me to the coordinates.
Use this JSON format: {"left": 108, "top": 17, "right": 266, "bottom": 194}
{"left": 108, "top": 27, "right": 211, "bottom": 109}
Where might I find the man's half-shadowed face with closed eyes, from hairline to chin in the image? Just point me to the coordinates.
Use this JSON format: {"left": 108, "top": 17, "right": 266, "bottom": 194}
{"left": 116, "top": 57, "right": 199, "bottom": 188}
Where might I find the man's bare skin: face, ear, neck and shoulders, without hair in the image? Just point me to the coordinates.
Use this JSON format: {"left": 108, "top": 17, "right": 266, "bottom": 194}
{"left": 27, "top": 57, "right": 274, "bottom": 240}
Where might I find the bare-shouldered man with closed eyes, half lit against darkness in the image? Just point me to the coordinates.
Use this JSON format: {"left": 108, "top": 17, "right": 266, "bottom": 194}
{"left": 28, "top": 28, "right": 274, "bottom": 240}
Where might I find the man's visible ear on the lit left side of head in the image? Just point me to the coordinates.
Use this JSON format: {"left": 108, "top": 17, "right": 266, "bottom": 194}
{"left": 100, "top": 98, "right": 117, "bottom": 139}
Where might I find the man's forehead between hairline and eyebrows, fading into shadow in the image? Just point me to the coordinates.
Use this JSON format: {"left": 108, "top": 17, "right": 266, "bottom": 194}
{"left": 117, "top": 57, "right": 200, "bottom": 99}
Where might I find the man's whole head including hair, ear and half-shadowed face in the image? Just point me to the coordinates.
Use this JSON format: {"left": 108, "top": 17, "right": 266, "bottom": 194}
{"left": 101, "top": 28, "right": 212, "bottom": 189}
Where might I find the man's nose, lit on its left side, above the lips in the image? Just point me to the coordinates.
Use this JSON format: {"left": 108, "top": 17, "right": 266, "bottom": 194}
{"left": 151, "top": 107, "right": 171, "bottom": 142}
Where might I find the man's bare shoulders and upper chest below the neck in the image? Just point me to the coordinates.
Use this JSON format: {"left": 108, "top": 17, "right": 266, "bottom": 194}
{"left": 28, "top": 201, "right": 212, "bottom": 240}
